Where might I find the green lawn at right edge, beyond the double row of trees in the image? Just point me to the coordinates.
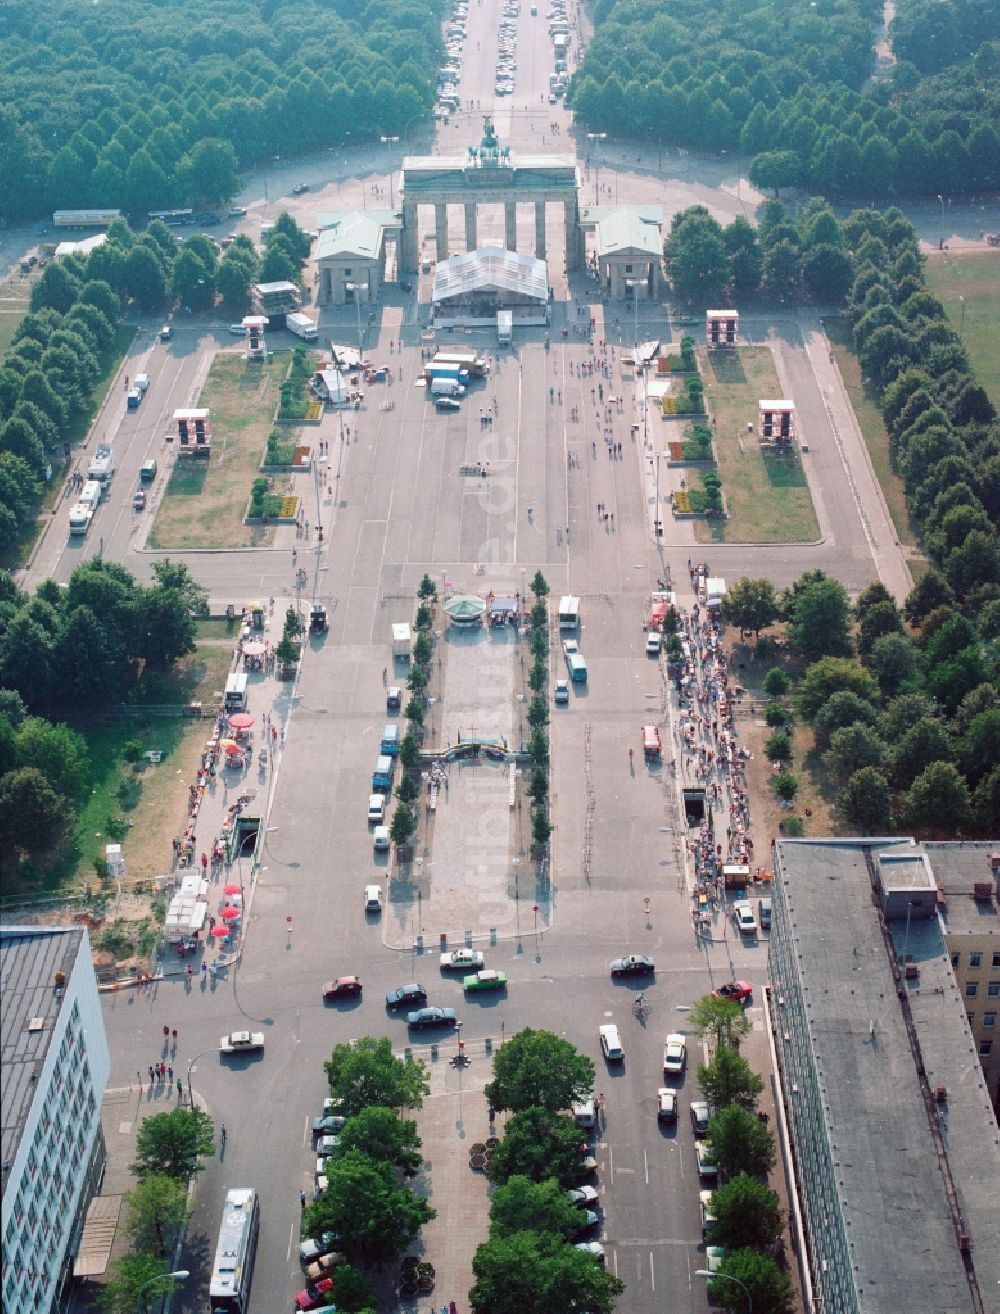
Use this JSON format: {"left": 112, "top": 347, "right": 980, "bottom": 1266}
{"left": 924, "top": 250, "right": 1000, "bottom": 409}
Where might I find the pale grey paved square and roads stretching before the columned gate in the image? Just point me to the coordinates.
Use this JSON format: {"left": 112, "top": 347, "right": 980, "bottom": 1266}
{"left": 78, "top": 5, "right": 909, "bottom": 1314}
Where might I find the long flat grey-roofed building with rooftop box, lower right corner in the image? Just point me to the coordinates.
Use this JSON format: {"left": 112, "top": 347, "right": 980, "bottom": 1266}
{"left": 769, "top": 838, "right": 1000, "bottom": 1314}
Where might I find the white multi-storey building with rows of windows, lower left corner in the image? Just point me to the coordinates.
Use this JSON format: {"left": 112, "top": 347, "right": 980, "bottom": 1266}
{"left": 0, "top": 926, "right": 110, "bottom": 1314}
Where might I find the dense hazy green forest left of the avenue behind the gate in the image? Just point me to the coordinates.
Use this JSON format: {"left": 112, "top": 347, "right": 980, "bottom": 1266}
{"left": 0, "top": 0, "right": 444, "bottom": 221}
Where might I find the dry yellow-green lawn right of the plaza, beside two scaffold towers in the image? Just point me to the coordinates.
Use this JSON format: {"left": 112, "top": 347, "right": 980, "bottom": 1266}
{"left": 677, "top": 347, "right": 820, "bottom": 543}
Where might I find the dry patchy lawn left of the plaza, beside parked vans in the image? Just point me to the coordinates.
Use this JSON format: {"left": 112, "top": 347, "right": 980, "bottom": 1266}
{"left": 147, "top": 352, "right": 288, "bottom": 549}
